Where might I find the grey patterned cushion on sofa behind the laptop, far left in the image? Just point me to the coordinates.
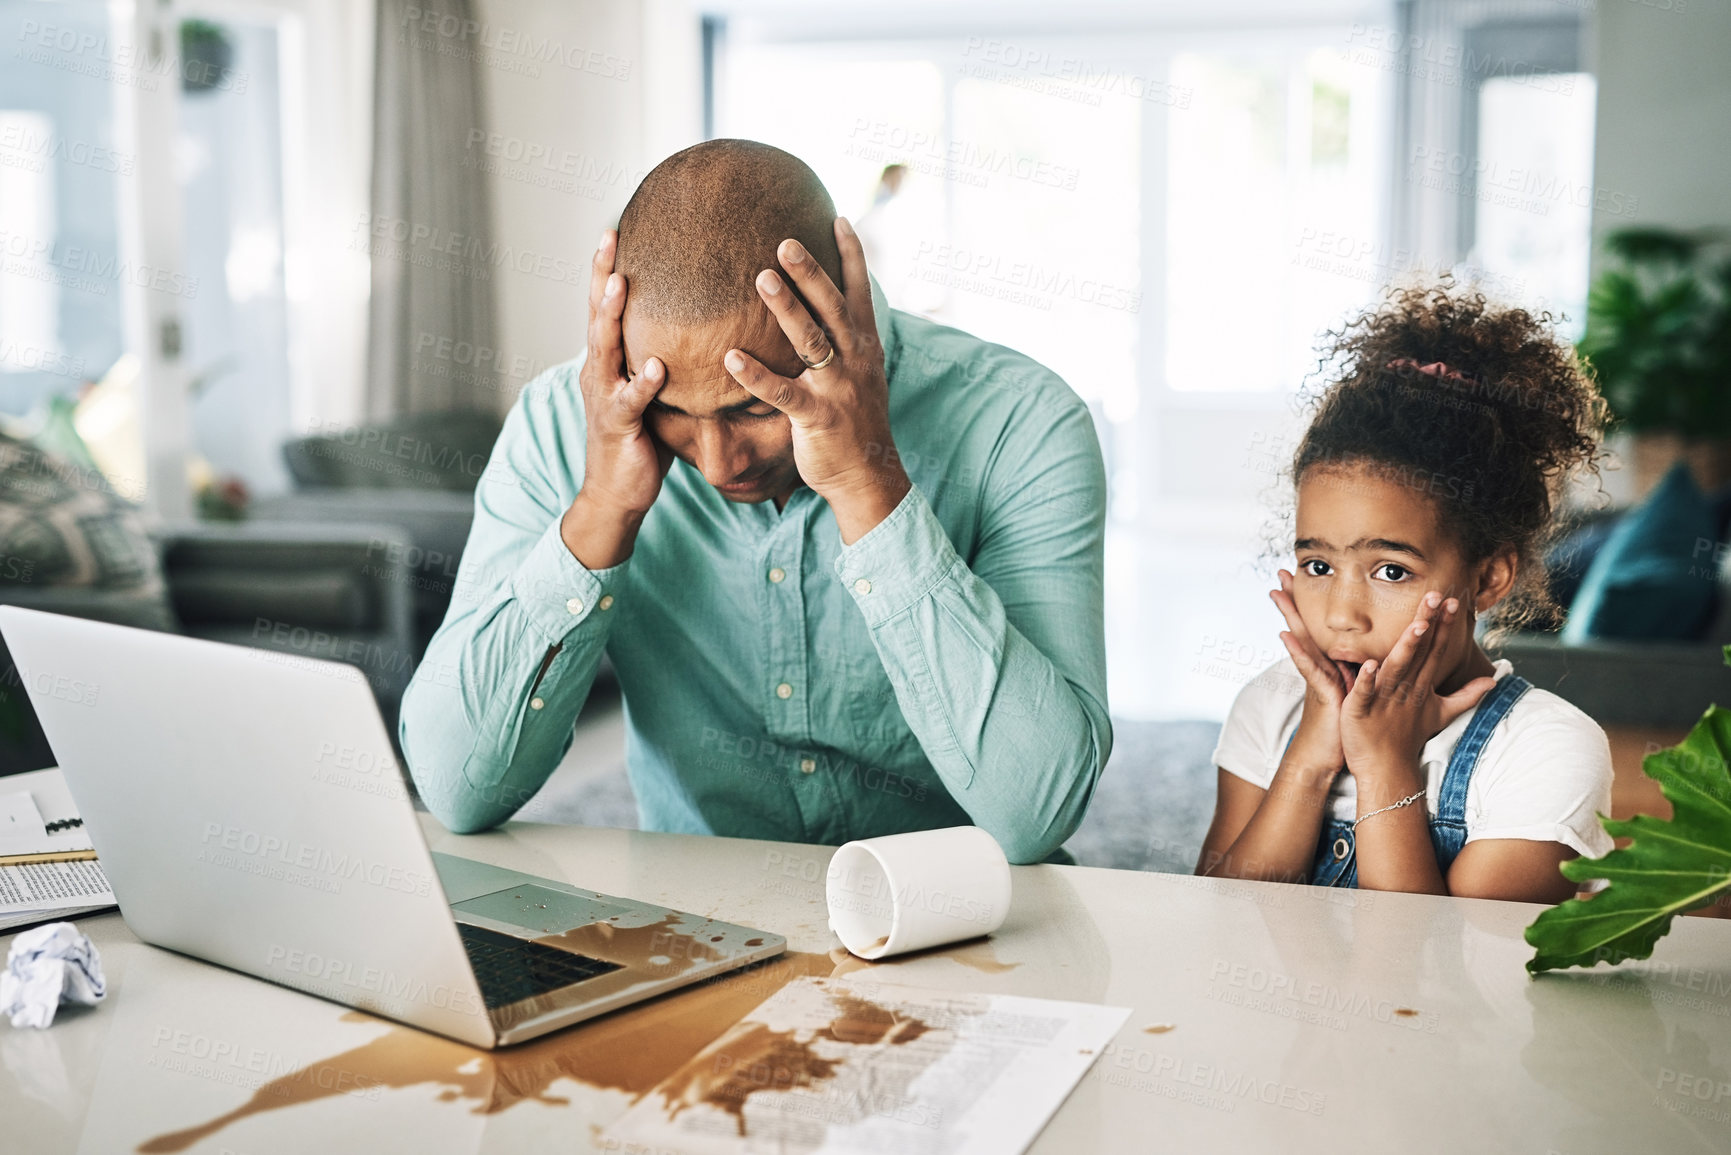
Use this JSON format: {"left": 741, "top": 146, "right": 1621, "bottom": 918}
{"left": 0, "top": 435, "right": 177, "bottom": 630}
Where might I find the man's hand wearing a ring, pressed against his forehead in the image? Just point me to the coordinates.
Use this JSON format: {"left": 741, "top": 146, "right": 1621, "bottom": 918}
{"left": 716, "top": 216, "right": 911, "bottom": 545}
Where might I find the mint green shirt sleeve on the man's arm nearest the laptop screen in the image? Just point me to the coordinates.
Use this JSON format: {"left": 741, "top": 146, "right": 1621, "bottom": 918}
{"left": 398, "top": 369, "right": 630, "bottom": 833}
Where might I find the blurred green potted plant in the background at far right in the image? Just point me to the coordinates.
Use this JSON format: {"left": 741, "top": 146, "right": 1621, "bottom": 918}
{"left": 1579, "top": 229, "right": 1731, "bottom": 497}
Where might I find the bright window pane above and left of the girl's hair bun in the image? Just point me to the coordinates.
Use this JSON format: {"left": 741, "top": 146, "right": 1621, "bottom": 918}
{"left": 1165, "top": 45, "right": 1388, "bottom": 391}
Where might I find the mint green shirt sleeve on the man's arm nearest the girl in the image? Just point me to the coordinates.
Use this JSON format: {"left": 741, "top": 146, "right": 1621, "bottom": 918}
{"left": 834, "top": 395, "right": 1111, "bottom": 862}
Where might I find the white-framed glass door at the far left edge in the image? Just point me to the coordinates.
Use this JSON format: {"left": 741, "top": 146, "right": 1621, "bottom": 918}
{"left": 0, "top": 0, "right": 193, "bottom": 519}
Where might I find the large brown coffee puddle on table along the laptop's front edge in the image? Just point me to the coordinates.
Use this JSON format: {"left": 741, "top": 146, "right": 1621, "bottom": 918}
{"left": 137, "top": 948, "right": 843, "bottom": 1155}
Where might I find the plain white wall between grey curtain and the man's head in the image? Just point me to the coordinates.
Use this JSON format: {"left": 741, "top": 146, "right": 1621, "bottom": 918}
{"left": 466, "top": 0, "right": 703, "bottom": 410}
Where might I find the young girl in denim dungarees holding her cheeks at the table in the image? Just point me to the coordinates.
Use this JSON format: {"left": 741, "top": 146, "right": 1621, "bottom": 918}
{"left": 1196, "top": 284, "right": 1612, "bottom": 902}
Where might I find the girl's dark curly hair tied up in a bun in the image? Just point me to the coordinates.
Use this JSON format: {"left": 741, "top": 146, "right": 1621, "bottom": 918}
{"left": 1291, "top": 279, "right": 1610, "bottom": 632}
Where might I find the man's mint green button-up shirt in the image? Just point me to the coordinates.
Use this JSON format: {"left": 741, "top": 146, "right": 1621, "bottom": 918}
{"left": 400, "top": 286, "right": 1111, "bottom": 862}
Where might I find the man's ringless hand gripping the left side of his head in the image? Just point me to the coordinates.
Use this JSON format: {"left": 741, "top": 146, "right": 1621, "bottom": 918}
{"left": 559, "top": 229, "right": 673, "bottom": 570}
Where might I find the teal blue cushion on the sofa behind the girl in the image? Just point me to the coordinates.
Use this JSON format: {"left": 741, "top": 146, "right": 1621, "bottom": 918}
{"left": 1561, "top": 462, "right": 1719, "bottom": 646}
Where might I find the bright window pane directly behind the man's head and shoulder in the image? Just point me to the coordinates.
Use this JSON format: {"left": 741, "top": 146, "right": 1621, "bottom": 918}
{"left": 717, "top": 43, "right": 1141, "bottom": 429}
